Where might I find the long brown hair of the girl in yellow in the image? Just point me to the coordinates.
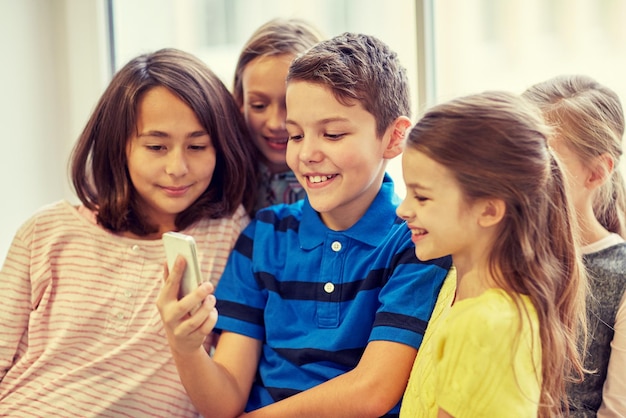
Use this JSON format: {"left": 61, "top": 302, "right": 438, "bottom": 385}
{"left": 407, "top": 92, "right": 586, "bottom": 417}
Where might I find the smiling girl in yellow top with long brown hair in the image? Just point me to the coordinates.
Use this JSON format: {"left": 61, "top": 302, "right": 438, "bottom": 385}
{"left": 397, "top": 92, "right": 586, "bottom": 418}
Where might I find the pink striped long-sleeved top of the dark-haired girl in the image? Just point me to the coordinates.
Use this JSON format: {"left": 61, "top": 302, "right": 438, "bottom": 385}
{"left": 0, "top": 202, "right": 249, "bottom": 418}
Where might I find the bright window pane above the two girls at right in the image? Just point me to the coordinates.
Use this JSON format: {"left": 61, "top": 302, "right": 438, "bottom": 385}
{"left": 427, "top": 0, "right": 626, "bottom": 173}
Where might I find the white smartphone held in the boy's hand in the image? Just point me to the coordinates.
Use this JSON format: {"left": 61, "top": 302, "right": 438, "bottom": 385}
{"left": 163, "top": 232, "right": 202, "bottom": 310}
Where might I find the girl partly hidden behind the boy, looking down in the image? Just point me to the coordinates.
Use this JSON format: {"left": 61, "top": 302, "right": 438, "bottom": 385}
{"left": 233, "top": 19, "right": 322, "bottom": 209}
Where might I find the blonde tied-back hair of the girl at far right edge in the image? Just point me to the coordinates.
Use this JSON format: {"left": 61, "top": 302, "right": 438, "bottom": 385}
{"left": 523, "top": 75, "right": 626, "bottom": 238}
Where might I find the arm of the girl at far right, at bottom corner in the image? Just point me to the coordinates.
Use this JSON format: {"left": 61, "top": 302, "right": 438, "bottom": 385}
{"left": 598, "top": 293, "right": 626, "bottom": 418}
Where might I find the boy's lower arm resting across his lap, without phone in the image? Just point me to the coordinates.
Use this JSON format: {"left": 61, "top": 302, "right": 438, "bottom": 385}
{"left": 241, "top": 341, "right": 417, "bottom": 418}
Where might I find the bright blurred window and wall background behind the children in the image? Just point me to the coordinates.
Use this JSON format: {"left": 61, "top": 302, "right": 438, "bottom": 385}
{"left": 0, "top": 0, "right": 626, "bottom": 262}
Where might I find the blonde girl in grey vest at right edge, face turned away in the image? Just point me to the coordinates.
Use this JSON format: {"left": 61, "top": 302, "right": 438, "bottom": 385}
{"left": 523, "top": 75, "right": 626, "bottom": 417}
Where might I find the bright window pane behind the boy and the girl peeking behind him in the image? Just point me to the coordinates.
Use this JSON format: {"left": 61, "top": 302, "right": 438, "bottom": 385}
{"left": 113, "top": 0, "right": 418, "bottom": 195}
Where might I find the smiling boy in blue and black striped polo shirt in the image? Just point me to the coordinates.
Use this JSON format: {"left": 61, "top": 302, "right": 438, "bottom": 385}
{"left": 158, "top": 33, "right": 450, "bottom": 417}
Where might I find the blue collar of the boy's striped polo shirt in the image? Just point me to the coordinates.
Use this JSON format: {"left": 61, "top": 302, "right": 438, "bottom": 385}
{"left": 298, "top": 173, "right": 400, "bottom": 249}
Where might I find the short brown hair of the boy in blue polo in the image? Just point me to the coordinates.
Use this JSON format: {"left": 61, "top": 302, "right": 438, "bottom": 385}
{"left": 287, "top": 32, "right": 411, "bottom": 136}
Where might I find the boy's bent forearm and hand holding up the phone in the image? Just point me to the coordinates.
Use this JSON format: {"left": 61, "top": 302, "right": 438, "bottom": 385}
{"left": 157, "top": 257, "right": 261, "bottom": 417}
